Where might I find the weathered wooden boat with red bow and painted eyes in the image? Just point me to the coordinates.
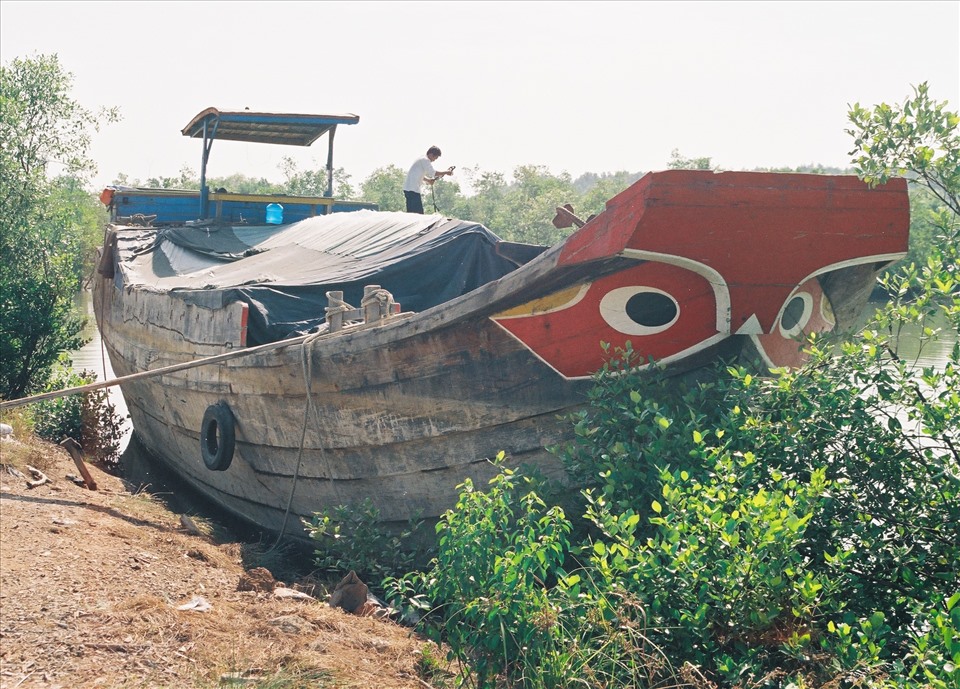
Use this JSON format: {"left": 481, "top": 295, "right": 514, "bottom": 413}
{"left": 95, "top": 113, "right": 909, "bottom": 537}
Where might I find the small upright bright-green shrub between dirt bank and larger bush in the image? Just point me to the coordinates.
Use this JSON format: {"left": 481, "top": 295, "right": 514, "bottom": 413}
{"left": 410, "top": 454, "right": 569, "bottom": 686}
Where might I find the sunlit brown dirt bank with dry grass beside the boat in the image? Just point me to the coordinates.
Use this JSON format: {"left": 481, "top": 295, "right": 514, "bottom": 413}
{"left": 0, "top": 438, "right": 454, "bottom": 689}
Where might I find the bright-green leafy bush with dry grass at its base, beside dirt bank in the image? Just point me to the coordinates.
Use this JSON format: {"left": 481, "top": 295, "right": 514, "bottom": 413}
{"left": 389, "top": 453, "right": 673, "bottom": 689}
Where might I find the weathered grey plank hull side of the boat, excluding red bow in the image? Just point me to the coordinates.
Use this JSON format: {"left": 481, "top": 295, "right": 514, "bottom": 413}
{"left": 96, "top": 272, "right": 600, "bottom": 532}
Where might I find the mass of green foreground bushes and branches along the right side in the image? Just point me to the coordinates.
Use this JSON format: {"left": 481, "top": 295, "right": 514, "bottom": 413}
{"left": 322, "top": 85, "right": 960, "bottom": 689}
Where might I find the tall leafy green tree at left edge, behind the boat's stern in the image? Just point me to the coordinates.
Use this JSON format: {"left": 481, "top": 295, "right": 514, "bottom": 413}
{"left": 0, "top": 56, "right": 115, "bottom": 397}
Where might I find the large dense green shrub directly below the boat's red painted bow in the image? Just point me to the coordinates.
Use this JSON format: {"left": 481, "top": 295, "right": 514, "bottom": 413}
{"left": 560, "top": 316, "right": 960, "bottom": 686}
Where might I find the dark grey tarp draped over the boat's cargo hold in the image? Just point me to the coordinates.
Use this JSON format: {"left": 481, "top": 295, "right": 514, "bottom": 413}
{"left": 118, "top": 210, "right": 536, "bottom": 345}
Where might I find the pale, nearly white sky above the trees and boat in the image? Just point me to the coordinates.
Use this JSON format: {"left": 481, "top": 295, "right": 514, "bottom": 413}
{"left": 0, "top": 0, "right": 960, "bottom": 194}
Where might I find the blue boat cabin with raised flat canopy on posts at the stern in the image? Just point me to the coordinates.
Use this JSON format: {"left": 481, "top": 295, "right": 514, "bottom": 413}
{"left": 100, "top": 108, "right": 377, "bottom": 225}
